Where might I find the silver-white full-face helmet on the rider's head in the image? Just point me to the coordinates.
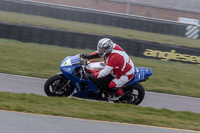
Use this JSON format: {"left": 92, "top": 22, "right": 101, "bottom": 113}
{"left": 97, "top": 38, "right": 113, "bottom": 57}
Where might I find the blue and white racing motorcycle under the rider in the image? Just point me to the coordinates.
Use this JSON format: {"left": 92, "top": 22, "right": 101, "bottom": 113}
{"left": 44, "top": 54, "right": 152, "bottom": 105}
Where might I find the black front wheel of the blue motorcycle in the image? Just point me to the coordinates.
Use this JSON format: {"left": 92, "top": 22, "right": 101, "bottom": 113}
{"left": 44, "top": 74, "right": 74, "bottom": 97}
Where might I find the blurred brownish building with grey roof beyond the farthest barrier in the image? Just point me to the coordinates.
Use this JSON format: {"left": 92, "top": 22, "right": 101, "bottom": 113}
{"left": 31, "top": 0, "right": 200, "bottom": 24}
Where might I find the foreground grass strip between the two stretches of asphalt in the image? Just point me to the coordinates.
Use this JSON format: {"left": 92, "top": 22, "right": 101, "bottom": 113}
{"left": 0, "top": 92, "right": 200, "bottom": 131}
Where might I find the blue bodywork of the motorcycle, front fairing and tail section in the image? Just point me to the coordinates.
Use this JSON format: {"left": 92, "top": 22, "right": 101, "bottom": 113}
{"left": 60, "top": 56, "right": 152, "bottom": 98}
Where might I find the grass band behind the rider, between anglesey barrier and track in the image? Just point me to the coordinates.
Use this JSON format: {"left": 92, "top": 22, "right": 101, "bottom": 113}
{"left": 0, "top": 39, "right": 200, "bottom": 97}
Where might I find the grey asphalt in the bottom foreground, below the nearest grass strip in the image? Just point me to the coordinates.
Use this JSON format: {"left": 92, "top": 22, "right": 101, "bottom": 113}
{"left": 0, "top": 111, "right": 198, "bottom": 133}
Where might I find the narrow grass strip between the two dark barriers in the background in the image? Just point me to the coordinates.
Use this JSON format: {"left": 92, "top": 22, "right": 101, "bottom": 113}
{"left": 0, "top": 11, "right": 200, "bottom": 48}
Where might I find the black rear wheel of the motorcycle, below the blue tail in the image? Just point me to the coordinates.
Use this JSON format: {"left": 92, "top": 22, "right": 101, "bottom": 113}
{"left": 122, "top": 83, "right": 145, "bottom": 105}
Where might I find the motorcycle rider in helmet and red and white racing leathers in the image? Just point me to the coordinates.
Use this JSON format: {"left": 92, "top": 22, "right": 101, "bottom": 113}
{"left": 80, "top": 38, "right": 134, "bottom": 101}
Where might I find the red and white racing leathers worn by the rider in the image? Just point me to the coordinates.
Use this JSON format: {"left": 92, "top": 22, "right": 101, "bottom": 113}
{"left": 90, "top": 43, "right": 134, "bottom": 96}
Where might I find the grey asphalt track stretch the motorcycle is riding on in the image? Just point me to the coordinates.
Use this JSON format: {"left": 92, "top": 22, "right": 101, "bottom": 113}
{"left": 0, "top": 73, "right": 200, "bottom": 113}
